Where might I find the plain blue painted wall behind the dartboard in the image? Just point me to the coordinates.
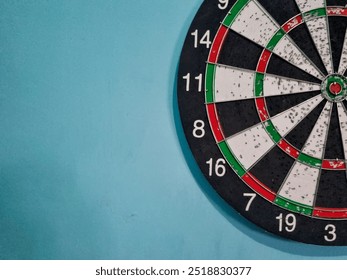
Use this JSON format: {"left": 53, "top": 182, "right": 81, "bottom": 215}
{"left": 0, "top": 0, "right": 347, "bottom": 259}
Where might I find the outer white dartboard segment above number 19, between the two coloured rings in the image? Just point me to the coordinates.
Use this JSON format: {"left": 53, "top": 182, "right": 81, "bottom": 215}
{"left": 279, "top": 161, "right": 320, "bottom": 206}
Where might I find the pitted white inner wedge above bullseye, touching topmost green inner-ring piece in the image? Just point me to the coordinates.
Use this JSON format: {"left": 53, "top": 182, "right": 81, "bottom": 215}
{"left": 306, "top": 17, "right": 334, "bottom": 74}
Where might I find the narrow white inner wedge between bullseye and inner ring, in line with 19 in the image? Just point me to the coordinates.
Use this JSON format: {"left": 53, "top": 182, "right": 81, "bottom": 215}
{"left": 302, "top": 102, "right": 333, "bottom": 159}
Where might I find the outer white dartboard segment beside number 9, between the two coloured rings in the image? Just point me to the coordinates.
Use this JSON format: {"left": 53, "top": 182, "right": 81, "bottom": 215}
{"left": 230, "top": 1, "right": 280, "bottom": 47}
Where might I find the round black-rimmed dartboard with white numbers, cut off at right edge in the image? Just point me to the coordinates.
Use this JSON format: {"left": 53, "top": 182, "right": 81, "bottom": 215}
{"left": 178, "top": 0, "right": 347, "bottom": 245}
